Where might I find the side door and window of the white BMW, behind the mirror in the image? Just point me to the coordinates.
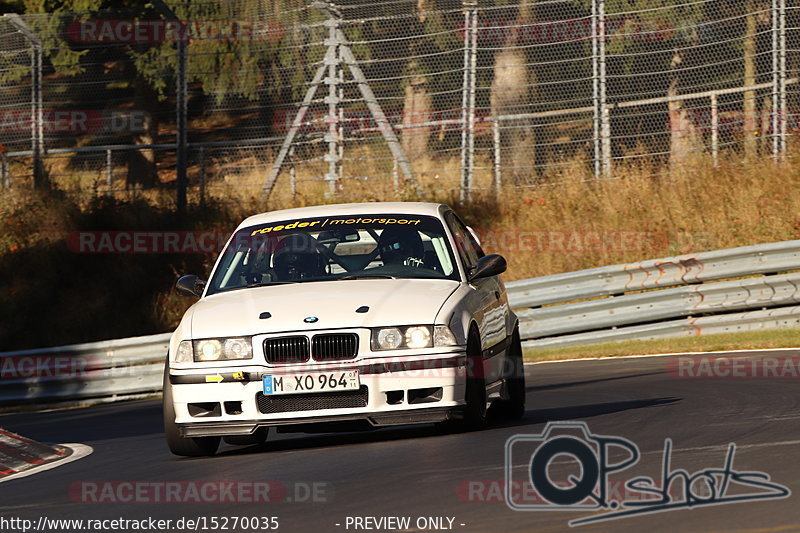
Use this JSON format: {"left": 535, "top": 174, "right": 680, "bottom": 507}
{"left": 445, "top": 211, "right": 508, "bottom": 394}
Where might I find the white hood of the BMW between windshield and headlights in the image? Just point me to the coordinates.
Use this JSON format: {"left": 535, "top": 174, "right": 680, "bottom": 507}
{"left": 190, "top": 279, "right": 459, "bottom": 338}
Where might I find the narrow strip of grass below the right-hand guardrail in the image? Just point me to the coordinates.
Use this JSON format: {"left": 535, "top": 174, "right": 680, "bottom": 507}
{"left": 525, "top": 329, "right": 800, "bottom": 363}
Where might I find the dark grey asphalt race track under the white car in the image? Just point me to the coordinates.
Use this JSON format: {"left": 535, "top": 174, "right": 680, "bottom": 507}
{"left": 0, "top": 351, "right": 800, "bottom": 533}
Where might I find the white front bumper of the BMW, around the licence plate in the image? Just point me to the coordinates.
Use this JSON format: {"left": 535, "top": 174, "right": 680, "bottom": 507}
{"left": 170, "top": 351, "right": 467, "bottom": 437}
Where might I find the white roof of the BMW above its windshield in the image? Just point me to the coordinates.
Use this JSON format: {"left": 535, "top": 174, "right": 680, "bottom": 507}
{"left": 239, "top": 202, "right": 447, "bottom": 228}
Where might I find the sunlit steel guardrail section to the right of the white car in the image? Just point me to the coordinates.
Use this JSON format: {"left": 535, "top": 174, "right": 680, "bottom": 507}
{"left": 506, "top": 240, "right": 800, "bottom": 348}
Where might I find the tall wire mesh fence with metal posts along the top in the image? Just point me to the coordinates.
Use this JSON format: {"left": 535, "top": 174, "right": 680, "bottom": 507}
{"left": 0, "top": 0, "right": 800, "bottom": 201}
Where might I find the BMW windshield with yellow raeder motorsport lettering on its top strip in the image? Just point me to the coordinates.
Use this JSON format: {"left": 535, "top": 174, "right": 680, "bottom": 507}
{"left": 203, "top": 214, "right": 459, "bottom": 294}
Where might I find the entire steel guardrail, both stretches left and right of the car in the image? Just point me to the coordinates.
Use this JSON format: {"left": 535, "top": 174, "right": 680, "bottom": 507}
{"left": 0, "top": 240, "right": 800, "bottom": 406}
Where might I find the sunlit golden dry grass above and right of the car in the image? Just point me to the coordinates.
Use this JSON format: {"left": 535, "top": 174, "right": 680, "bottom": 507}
{"left": 192, "top": 145, "right": 800, "bottom": 279}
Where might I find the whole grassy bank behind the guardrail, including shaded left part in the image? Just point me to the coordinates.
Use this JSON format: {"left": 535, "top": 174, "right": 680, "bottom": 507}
{"left": 0, "top": 148, "right": 800, "bottom": 346}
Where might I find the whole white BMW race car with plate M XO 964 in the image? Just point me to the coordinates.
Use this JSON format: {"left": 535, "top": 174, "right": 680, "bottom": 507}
{"left": 164, "top": 202, "right": 525, "bottom": 456}
